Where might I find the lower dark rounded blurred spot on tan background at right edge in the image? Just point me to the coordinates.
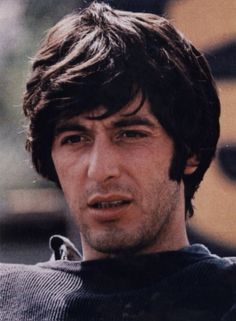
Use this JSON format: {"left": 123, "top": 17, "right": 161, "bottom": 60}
{"left": 217, "top": 144, "right": 236, "bottom": 182}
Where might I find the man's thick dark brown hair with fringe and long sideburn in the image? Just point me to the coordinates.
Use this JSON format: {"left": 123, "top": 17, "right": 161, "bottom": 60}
{"left": 23, "top": 2, "right": 220, "bottom": 216}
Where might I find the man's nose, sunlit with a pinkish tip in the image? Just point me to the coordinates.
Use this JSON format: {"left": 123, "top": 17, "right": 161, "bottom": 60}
{"left": 87, "top": 137, "right": 120, "bottom": 183}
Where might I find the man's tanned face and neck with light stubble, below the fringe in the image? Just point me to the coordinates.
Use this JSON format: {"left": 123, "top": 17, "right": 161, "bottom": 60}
{"left": 52, "top": 97, "right": 186, "bottom": 259}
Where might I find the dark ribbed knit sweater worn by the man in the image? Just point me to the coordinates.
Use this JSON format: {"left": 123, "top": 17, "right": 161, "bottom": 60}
{"left": 0, "top": 234, "right": 236, "bottom": 321}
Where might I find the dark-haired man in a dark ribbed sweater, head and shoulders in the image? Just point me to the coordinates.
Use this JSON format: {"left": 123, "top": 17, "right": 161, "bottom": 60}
{"left": 0, "top": 3, "right": 236, "bottom": 321}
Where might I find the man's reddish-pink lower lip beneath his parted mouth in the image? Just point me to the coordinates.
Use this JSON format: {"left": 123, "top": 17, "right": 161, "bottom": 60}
{"left": 89, "top": 203, "right": 131, "bottom": 222}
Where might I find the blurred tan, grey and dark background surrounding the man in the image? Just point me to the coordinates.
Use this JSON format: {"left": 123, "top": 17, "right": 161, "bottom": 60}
{"left": 0, "top": 0, "right": 236, "bottom": 264}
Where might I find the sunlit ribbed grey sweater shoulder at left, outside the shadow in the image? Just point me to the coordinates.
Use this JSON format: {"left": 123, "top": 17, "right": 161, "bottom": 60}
{"left": 0, "top": 261, "right": 81, "bottom": 320}
